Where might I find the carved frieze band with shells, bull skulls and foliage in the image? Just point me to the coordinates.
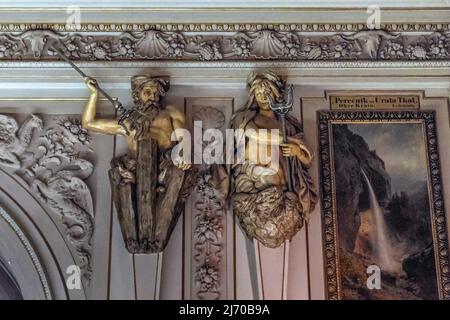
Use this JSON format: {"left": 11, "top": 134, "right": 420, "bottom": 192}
{"left": 0, "top": 29, "right": 450, "bottom": 64}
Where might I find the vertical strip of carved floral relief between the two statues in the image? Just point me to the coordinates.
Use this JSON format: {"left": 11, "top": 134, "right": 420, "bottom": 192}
{"left": 193, "top": 107, "right": 226, "bottom": 299}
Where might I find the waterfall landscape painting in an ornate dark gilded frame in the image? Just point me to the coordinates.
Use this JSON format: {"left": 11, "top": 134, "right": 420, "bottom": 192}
{"left": 318, "top": 111, "right": 450, "bottom": 300}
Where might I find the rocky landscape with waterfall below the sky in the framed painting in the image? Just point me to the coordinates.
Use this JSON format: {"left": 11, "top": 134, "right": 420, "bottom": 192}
{"left": 333, "top": 124, "right": 438, "bottom": 300}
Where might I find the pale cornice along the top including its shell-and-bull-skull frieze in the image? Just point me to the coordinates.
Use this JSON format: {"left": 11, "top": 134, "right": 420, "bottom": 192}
{"left": 0, "top": 0, "right": 450, "bottom": 67}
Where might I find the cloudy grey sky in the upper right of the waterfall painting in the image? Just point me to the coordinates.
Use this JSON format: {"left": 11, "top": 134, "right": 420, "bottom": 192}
{"left": 348, "top": 123, "right": 427, "bottom": 192}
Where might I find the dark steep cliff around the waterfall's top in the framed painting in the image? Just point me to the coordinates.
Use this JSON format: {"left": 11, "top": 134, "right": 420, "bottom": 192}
{"left": 333, "top": 124, "right": 391, "bottom": 251}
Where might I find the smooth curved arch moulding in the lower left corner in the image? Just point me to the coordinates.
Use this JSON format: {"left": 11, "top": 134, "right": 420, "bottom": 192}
{"left": 0, "top": 170, "right": 86, "bottom": 299}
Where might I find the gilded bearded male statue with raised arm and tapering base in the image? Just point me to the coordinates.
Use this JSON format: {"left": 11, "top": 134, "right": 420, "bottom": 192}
{"left": 82, "top": 76, "right": 193, "bottom": 253}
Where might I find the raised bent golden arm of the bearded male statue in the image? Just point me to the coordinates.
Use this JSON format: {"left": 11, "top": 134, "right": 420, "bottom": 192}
{"left": 81, "top": 78, "right": 126, "bottom": 135}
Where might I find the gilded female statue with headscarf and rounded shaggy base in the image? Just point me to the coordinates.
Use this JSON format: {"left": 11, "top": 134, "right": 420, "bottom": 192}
{"left": 231, "top": 71, "right": 317, "bottom": 248}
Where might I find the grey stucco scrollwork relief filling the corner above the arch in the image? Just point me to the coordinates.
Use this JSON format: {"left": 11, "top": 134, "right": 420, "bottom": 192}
{"left": 0, "top": 115, "right": 94, "bottom": 283}
